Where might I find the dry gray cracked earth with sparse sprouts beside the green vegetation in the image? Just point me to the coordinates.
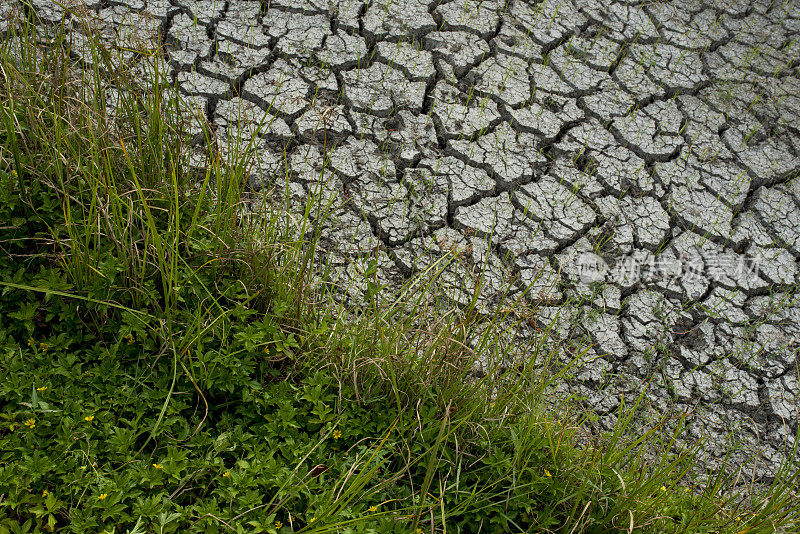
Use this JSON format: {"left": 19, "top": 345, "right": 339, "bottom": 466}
{"left": 9, "top": 0, "right": 800, "bottom": 480}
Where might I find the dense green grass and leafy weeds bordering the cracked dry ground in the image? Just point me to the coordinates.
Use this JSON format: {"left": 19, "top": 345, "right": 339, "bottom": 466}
{"left": 0, "top": 8, "right": 800, "bottom": 534}
